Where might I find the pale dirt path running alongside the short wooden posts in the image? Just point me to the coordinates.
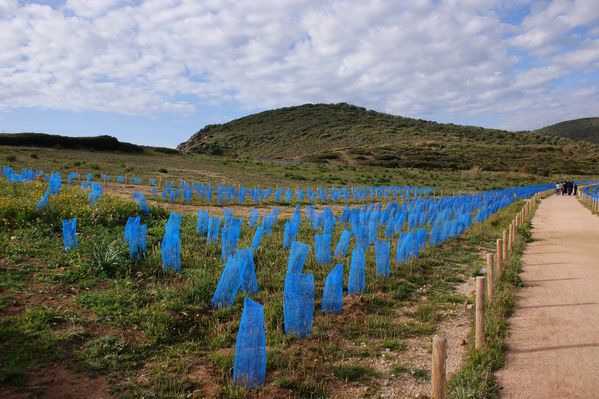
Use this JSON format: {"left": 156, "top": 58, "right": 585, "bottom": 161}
{"left": 497, "top": 196, "right": 599, "bottom": 399}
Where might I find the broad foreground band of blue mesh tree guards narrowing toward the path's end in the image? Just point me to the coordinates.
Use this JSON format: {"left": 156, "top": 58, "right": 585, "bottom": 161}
{"left": 54, "top": 181, "right": 551, "bottom": 387}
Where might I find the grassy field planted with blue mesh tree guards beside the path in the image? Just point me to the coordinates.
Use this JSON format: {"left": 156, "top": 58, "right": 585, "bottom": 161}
{"left": 0, "top": 158, "right": 564, "bottom": 398}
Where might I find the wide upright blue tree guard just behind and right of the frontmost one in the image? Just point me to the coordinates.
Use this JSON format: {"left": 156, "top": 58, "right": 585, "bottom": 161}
{"left": 283, "top": 273, "right": 314, "bottom": 337}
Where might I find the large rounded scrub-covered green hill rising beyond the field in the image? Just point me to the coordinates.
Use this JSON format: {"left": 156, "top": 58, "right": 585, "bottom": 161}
{"left": 178, "top": 104, "right": 599, "bottom": 173}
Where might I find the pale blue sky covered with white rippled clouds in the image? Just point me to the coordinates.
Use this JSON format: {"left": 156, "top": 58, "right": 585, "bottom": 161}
{"left": 0, "top": 0, "right": 599, "bottom": 147}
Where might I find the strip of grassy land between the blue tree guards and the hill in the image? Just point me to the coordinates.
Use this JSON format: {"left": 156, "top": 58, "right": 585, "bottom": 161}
{"left": 0, "top": 146, "right": 588, "bottom": 195}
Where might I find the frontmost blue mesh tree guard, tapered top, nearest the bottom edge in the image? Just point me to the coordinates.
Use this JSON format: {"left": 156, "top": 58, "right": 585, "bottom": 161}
{"left": 233, "top": 297, "right": 266, "bottom": 388}
